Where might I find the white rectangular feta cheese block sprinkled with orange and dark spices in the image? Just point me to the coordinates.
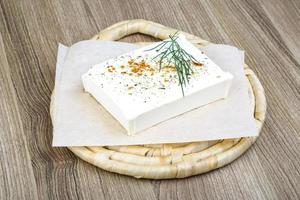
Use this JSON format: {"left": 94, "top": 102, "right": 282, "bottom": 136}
{"left": 82, "top": 35, "right": 233, "bottom": 135}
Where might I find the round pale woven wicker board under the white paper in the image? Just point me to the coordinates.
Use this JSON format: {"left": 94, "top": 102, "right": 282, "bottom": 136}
{"left": 50, "top": 20, "right": 266, "bottom": 179}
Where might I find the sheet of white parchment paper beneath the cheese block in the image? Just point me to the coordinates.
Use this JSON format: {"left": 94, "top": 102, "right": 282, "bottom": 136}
{"left": 53, "top": 41, "right": 258, "bottom": 146}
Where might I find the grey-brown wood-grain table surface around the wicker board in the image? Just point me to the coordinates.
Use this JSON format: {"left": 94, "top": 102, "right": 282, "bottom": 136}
{"left": 0, "top": 0, "right": 300, "bottom": 199}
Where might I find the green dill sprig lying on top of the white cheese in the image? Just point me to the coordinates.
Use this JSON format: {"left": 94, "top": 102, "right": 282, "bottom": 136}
{"left": 147, "top": 32, "right": 198, "bottom": 96}
